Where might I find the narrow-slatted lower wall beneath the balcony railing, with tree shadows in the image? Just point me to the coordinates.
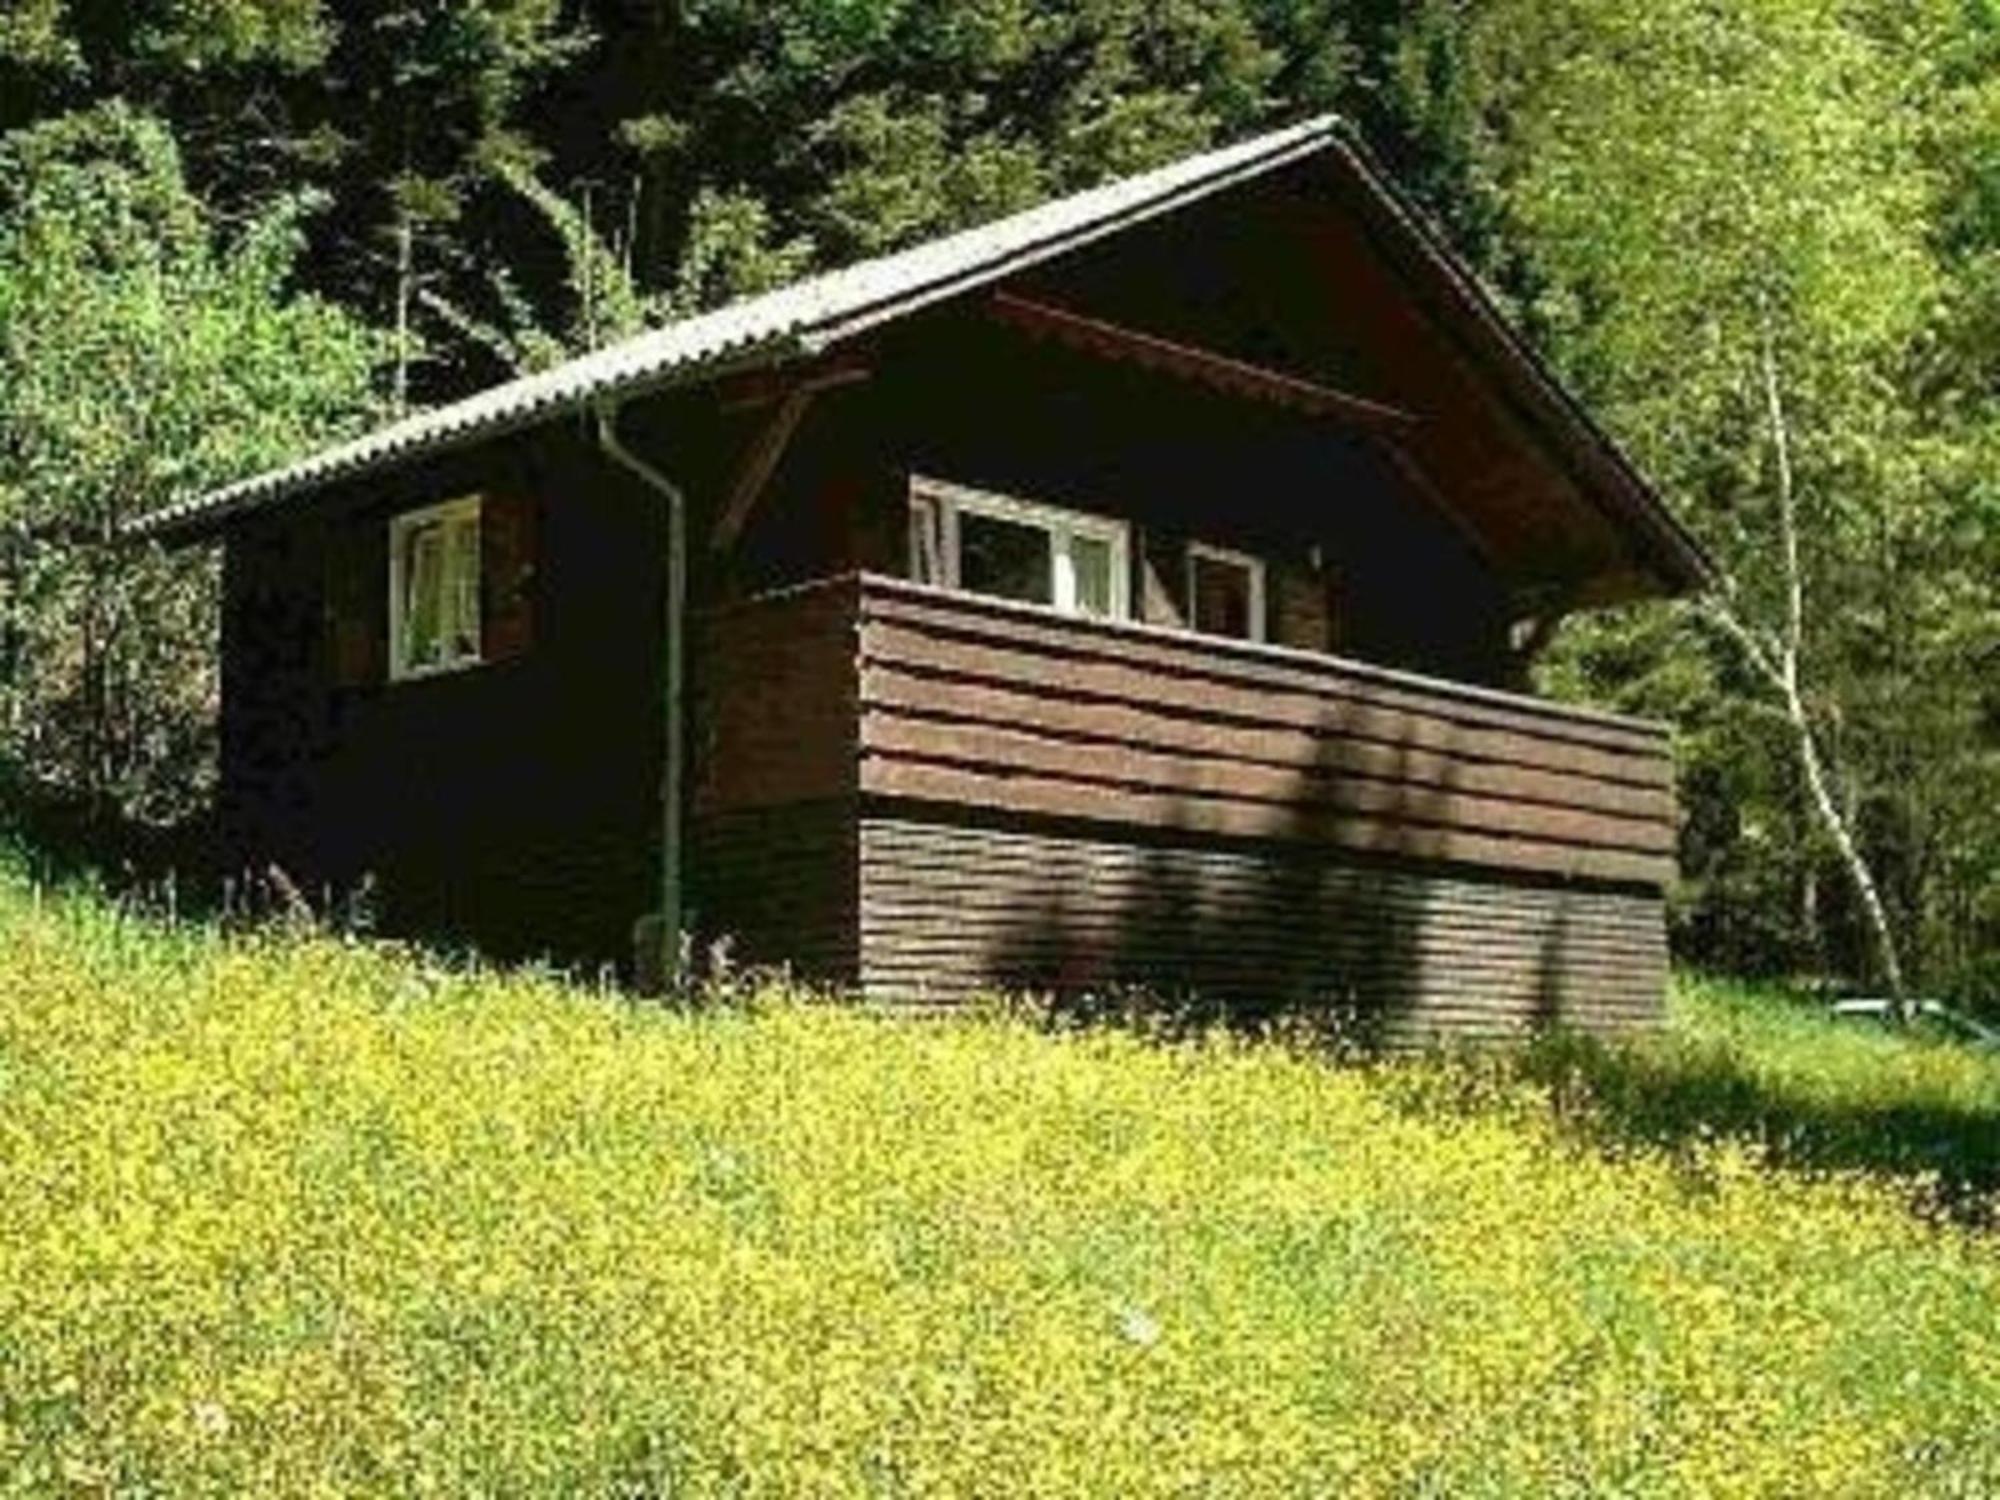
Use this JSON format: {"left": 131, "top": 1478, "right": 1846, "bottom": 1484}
{"left": 860, "top": 814, "right": 1666, "bottom": 1042}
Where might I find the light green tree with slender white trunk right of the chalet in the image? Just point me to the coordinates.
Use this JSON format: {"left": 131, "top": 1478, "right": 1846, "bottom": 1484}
{"left": 1472, "top": 0, "right": 1994, "bottom": 1012}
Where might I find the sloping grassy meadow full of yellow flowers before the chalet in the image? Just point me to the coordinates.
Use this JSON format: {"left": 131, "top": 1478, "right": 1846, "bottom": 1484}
{"left": 0, "top": 878, "right": 2000, "bottom": 1496}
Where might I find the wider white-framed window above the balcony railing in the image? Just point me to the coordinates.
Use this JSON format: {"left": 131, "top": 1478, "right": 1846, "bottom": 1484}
{"left": 910, "top": 478, "right": 1132, "bottom": 620}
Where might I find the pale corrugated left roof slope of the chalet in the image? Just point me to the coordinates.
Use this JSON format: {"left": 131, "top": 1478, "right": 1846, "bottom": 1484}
{"left": 126, "top": 116, "right": 1348, "bottom": 542}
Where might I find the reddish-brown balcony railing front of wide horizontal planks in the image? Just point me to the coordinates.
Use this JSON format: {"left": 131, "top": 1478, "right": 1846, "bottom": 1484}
{"left": 858, "top": 578, "right": 1674, "bottom": 888}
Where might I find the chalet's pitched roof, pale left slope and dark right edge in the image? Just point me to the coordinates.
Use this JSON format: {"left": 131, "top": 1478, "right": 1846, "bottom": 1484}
{"left": 130, "top": 116, "right": 1712, "bottom": 588}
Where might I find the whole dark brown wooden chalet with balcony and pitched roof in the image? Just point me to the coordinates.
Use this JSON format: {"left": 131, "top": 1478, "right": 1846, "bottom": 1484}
{"left": 140, "top": 120, "right": 1706, "bottom": 1036}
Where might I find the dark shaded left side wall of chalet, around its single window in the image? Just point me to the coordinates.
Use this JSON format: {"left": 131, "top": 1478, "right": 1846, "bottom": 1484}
{"left": 220, "top": 432, "right": 664, "bottom": 962}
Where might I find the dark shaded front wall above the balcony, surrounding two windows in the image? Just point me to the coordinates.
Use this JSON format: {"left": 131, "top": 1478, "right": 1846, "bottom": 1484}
{"left": 714, "top": 326, "right": 1514, "bottom": 684}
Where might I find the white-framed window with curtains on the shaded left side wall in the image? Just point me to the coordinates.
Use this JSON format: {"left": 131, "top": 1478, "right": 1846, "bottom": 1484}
{"left": 388, "top": 494, "right": 480, "bottom": 682}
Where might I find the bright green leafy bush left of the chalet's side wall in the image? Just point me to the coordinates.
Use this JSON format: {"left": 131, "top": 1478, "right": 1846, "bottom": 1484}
{"left": 0, "top": 108, "right": 380, "bottom": 818}
